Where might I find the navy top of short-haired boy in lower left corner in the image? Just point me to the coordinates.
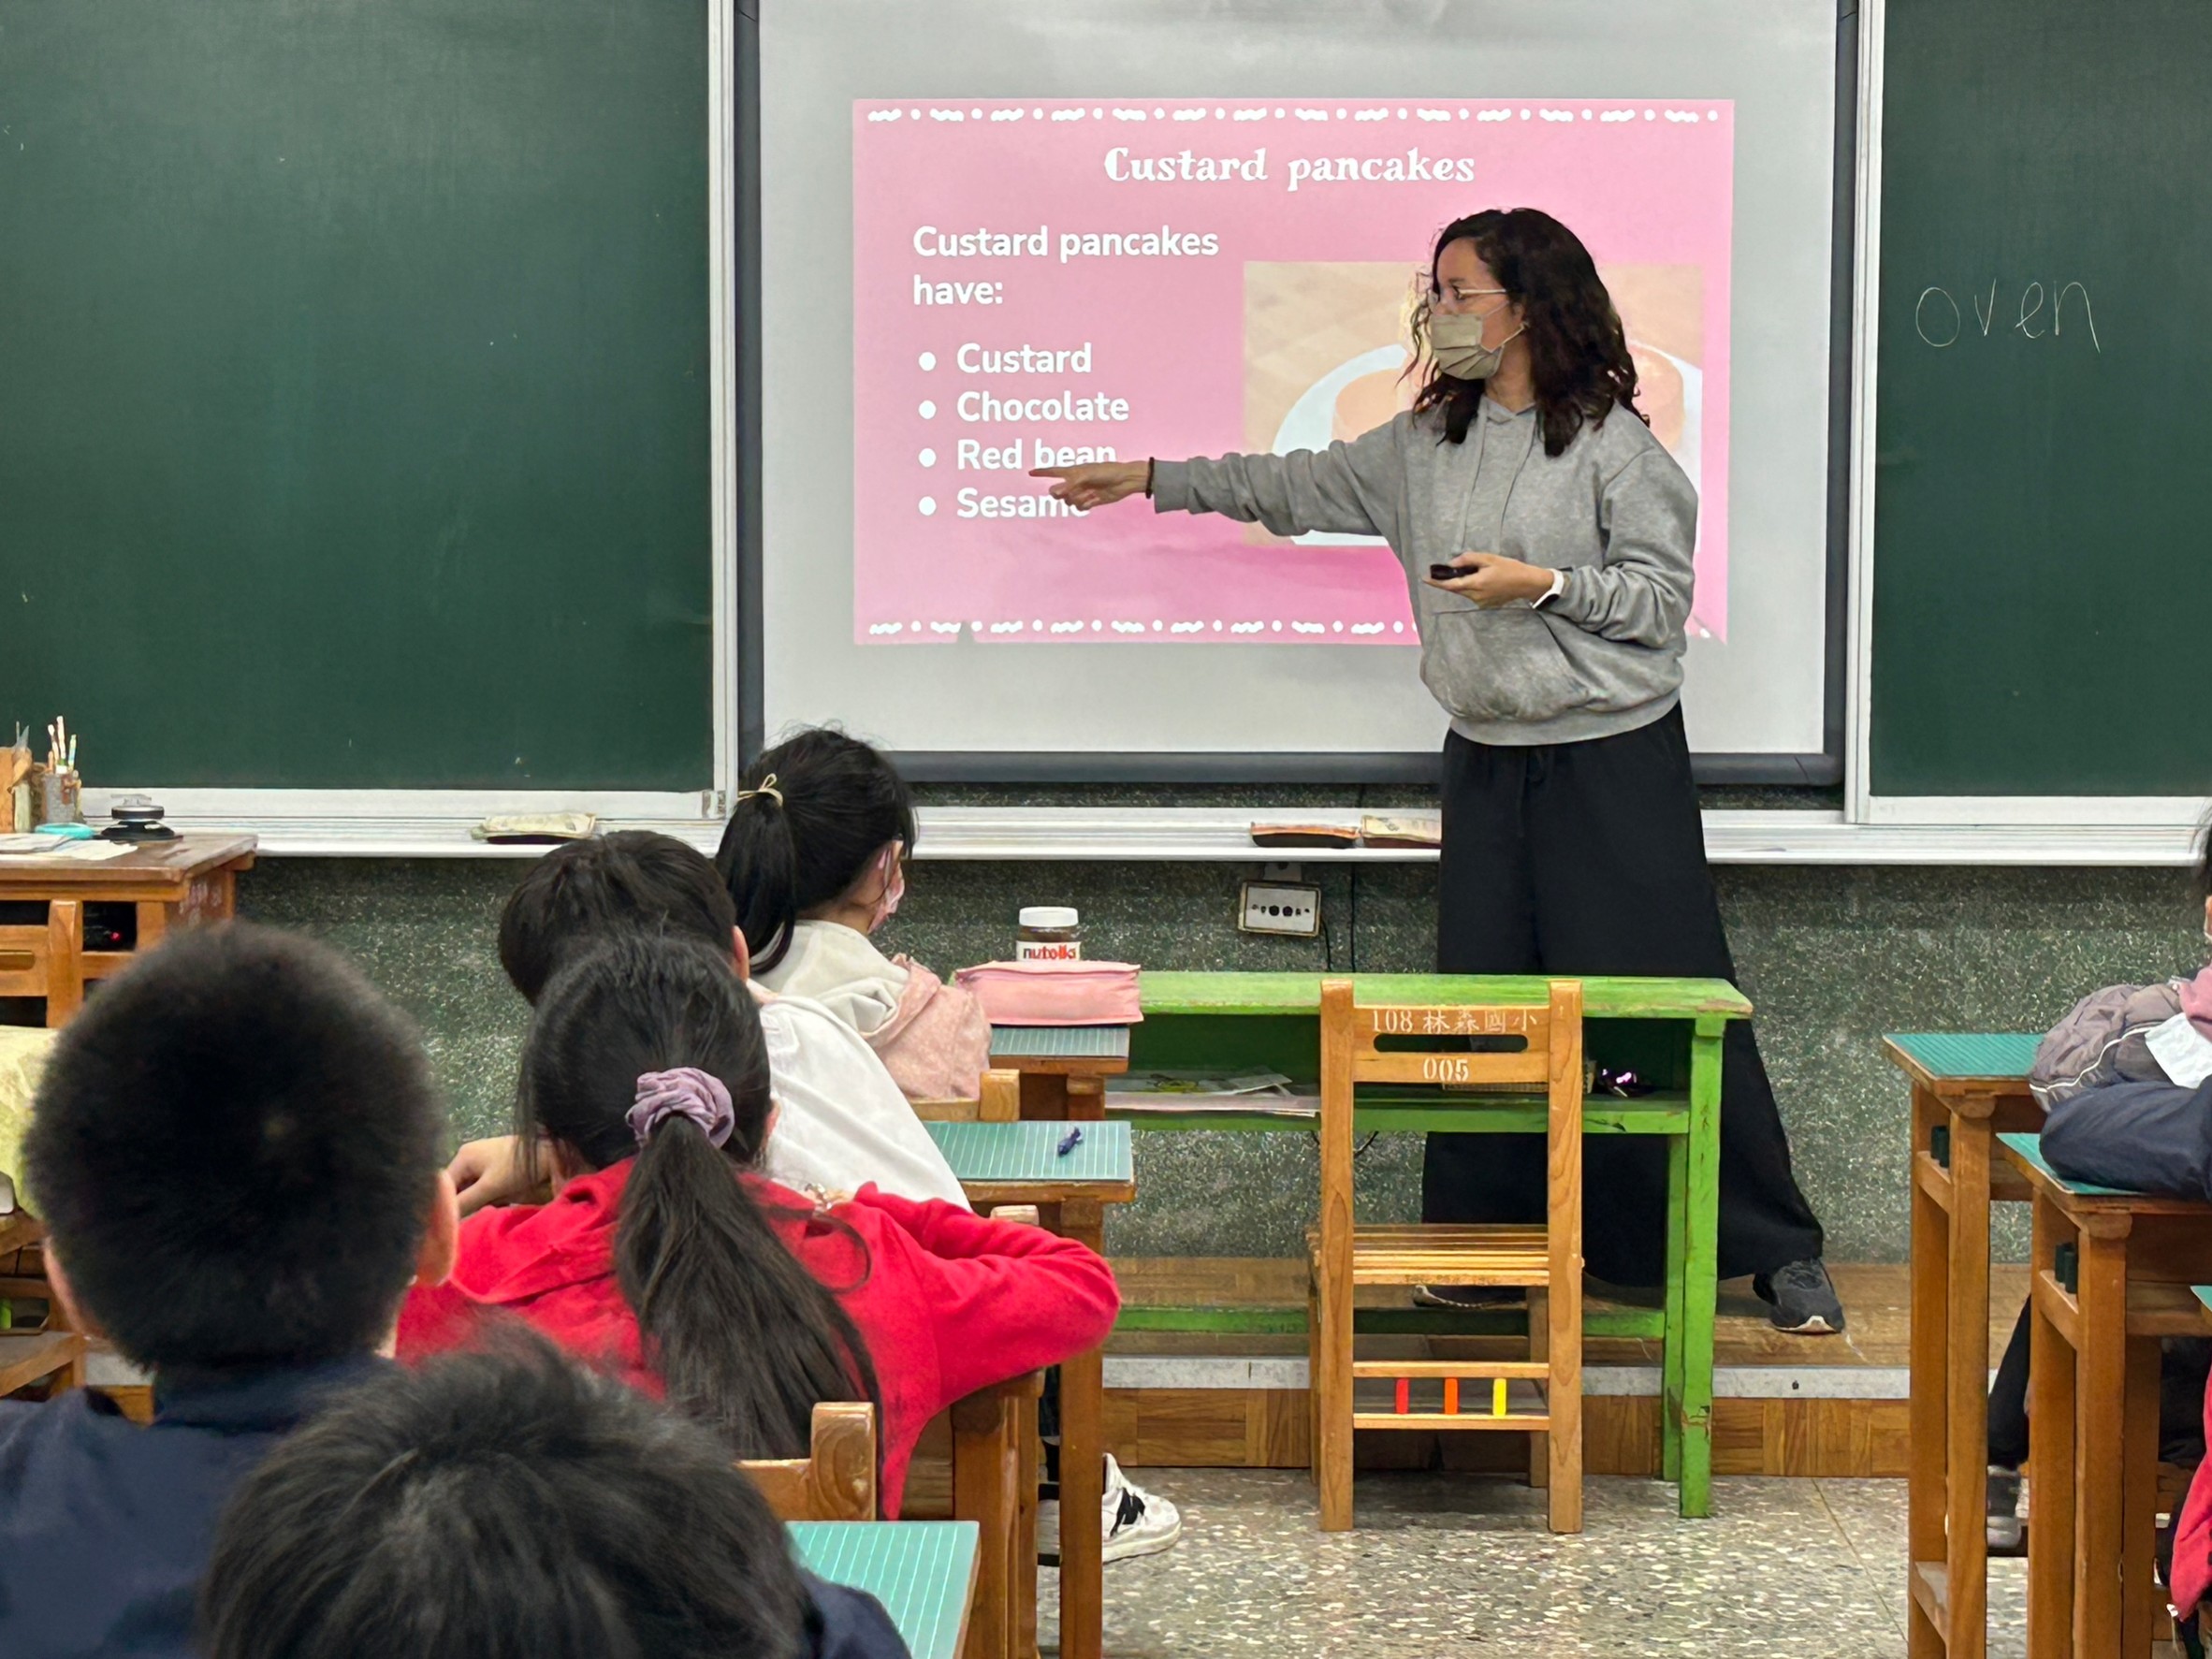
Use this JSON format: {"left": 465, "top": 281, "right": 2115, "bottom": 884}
{"left": 0, "top": 1356, "right": 389, "bottom": 1659}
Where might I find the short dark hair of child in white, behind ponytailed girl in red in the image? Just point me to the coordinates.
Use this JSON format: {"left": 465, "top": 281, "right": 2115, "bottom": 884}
{"left": 500, "top": 830, "right": 736, "bottom": 1002}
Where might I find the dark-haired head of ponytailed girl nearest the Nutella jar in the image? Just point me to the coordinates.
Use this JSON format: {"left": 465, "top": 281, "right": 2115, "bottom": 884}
{"left": 715, "top": 728, "right": 913, "bottom": 973}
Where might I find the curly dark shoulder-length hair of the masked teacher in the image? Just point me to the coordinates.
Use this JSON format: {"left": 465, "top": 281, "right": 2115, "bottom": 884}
{"left": 1414, "top": 208, "right": 1651, "bottom": 456}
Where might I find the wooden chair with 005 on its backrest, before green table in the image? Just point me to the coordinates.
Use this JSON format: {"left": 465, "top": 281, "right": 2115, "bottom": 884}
{"left": 1307, "top": 980, "right": 1581, "bottom": 1533}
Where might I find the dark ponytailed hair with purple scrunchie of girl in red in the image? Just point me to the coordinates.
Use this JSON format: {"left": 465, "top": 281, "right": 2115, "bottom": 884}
{"left": 517, "top": 934, "right": 876, "bottom": 1458}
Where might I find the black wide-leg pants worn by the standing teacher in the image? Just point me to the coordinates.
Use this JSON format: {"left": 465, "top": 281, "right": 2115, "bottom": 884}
{"left": 1420, "top": 707, "right": 1821, "bottom": 1285}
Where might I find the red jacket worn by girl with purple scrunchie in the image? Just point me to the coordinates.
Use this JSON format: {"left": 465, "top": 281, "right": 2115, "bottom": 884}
{"left": 399, "top": 1161, "right": 1122, "bottom": 1518}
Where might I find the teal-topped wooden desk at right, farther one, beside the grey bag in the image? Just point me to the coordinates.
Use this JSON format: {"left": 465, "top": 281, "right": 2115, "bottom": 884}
{"left": 1883, "top": 1031, "right": 2044, "bottom": 1659}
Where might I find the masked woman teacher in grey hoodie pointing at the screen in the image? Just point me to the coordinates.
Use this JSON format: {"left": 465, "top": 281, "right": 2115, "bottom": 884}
{"left": 1035, "top": 208, "right": 1842, "bottom": 1332}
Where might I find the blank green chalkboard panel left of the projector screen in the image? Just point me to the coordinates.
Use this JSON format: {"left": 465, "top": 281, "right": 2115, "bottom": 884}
{"left": 0, "top": 0, "right": 712, "bottom": 790}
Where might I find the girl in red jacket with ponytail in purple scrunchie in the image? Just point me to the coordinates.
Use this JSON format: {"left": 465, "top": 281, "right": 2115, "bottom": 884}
{"left": 400, "top": 934, "right": 1119, "bottom": 1515}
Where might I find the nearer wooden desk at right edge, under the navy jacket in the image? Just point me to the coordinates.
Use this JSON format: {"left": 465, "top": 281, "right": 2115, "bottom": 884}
{"left": 1998, "top": 1135, "right": 2212, "bottom": 1659}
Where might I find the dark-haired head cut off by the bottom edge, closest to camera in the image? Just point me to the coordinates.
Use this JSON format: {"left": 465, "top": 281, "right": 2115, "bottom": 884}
{"left": 201, "top": 1345, "right": 808, "bottom": 1659}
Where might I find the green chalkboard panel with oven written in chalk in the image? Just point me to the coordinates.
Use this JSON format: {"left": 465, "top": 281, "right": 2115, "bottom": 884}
{"left": 1871, "top": 0, "right": 2212, "bottom": 796}
